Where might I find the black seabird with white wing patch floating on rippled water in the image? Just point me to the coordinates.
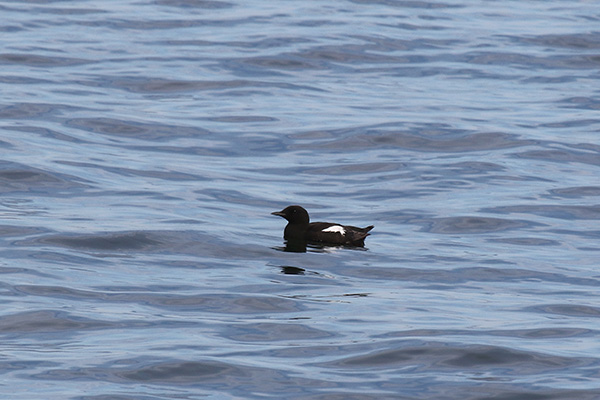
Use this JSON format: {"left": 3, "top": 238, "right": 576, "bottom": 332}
{"left": 271, "top": 206, "right": 373, "bottom": 247}
